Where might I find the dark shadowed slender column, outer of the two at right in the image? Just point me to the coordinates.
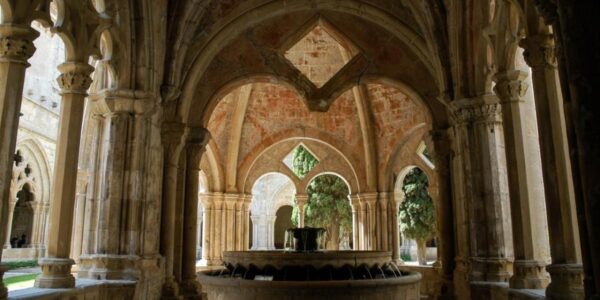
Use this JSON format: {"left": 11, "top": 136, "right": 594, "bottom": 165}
{"left": 521, "top": 32, "right": 584, "bottom": 299}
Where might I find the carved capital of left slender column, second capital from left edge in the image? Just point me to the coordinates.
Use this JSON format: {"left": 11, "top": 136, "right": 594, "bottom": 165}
{"left": 56, "top": 62, "right": 94, "bottom": 95}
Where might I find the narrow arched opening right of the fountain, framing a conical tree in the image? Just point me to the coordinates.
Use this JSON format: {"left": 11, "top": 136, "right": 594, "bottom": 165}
{"left": 395, "top": 166, "right": 438, "bottom": 266}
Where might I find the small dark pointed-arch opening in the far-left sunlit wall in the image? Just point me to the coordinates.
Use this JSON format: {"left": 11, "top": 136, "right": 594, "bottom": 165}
{"left": 10, "top": 184, "right": 34, "bottom": 248}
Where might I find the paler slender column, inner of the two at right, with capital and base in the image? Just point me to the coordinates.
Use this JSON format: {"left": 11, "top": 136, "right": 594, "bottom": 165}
{"left": 494, "top": 70, "right": 549, "bottom": 289}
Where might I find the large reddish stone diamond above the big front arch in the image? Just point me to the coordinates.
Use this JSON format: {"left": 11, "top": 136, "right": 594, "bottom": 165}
{"left": 285, "top": 25, "right": 351, "bottom": 88}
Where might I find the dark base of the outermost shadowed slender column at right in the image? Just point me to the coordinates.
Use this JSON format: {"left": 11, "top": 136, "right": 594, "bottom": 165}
{"left": 546, "top": 264, "right": 585, "bottom": 300}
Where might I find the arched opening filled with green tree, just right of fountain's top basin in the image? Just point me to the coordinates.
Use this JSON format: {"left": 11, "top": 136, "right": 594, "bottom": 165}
{"left": 304, "top": 174, "right": 353, "bottom": 250}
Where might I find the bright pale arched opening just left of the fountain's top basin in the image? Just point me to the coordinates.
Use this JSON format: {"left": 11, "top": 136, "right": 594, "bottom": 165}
{"left": 250, "top": 173, "right": 296, "bottom": 250}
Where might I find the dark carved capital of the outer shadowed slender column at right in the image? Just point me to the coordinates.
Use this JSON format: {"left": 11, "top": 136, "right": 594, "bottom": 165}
{"left": 519, "top": 34, "right": 558, "bottom": 68}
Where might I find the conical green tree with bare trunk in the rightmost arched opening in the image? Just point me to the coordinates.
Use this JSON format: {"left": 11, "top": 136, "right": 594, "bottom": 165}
{"left": 398, "top": 168, "right": 435, "bottom": 265}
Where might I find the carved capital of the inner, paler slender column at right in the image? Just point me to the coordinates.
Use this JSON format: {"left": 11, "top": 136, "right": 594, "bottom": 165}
{"left": 494, "top": 70, "right": 529, "bottom": 103}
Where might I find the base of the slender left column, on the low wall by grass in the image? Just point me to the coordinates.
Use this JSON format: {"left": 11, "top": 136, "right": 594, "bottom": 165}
{"left": 34, "top": 258, "right": 75, "bottom": 289}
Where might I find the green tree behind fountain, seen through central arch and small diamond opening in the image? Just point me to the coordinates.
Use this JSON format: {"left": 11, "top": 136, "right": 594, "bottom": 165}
{"left": 292, "top": 146, "right": 352, "bottom": 250}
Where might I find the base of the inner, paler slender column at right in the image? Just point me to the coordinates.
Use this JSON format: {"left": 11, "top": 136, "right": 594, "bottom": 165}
{"left": 510, "top": 260, "right": 550, "bottom": 290}
